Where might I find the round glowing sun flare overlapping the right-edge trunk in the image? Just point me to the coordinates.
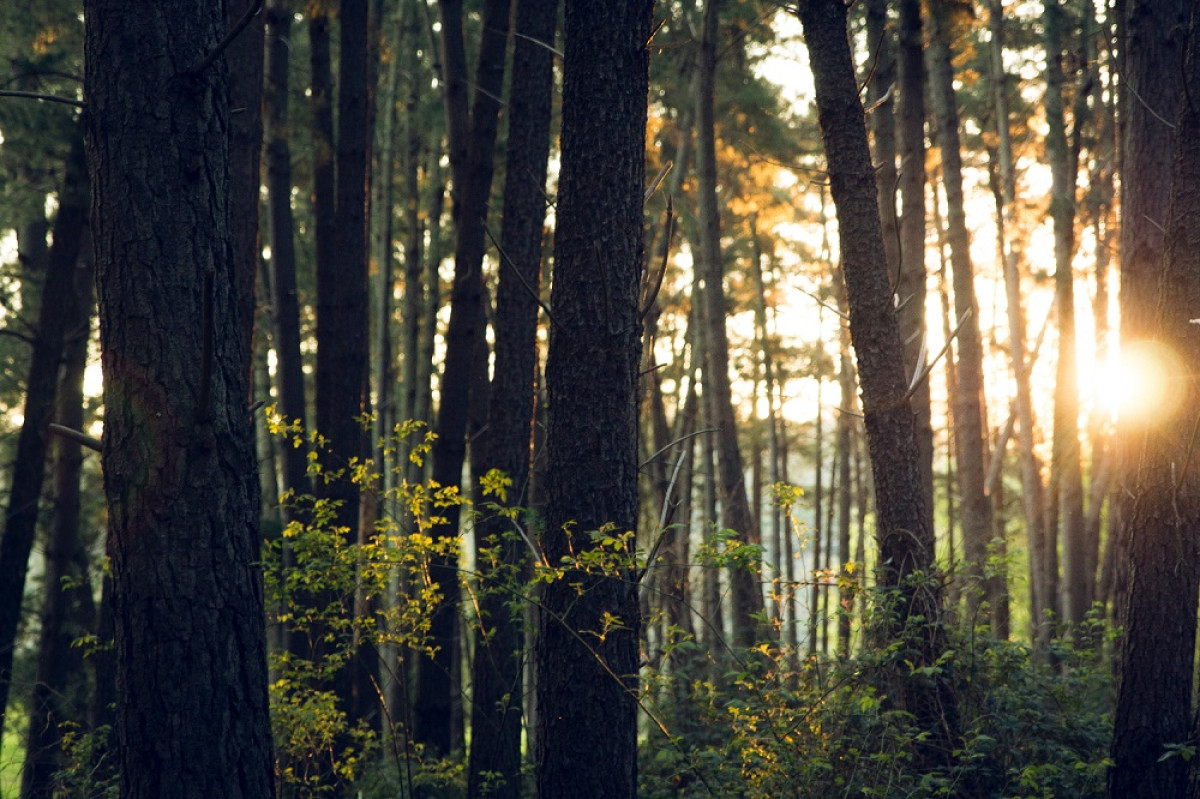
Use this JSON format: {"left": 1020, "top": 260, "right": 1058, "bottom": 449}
{"left": 1097, "top": 341, "right": 1184, "bottom": 423}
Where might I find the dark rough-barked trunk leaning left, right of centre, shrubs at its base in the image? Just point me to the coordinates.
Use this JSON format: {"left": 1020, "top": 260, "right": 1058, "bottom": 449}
{"left": 799, "top": 0, "right": 958, "bottom": 768}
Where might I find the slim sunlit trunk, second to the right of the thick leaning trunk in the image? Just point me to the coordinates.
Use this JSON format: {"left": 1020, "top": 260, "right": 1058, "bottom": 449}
{"left": 929, "top": 0, "right": 992, "bottom": 618}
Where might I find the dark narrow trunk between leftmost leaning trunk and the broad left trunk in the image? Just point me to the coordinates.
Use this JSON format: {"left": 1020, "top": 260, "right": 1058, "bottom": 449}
{"left": 20, "top": 140, "right": 96, "bottom": 798}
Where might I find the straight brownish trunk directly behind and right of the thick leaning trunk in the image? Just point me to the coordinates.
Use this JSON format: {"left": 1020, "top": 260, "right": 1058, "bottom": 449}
{"left": 896, "top": 0, "right": 934, "bottom": 530}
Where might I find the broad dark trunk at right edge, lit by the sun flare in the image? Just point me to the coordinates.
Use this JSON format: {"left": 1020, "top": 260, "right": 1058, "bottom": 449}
{"left": 1108, "top": 2, "right": 1200, "bottom": 798}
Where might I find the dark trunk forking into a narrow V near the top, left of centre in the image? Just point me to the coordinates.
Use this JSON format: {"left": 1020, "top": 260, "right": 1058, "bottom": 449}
{"left": 413, "top": 0, "right": 509, "bottom": 753}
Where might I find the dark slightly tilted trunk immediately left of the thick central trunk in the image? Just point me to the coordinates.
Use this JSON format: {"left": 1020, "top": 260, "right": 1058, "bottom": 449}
{"left": 467, "top": 0, "right": 558, "bottom": 799}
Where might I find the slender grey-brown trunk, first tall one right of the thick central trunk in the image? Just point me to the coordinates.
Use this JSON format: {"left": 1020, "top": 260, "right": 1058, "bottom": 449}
{"left": 696, "top": 0, "right": 767, "bottom": 647}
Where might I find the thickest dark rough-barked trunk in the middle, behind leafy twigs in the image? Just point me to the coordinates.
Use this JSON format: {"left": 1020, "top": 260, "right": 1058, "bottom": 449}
{"left": 536, "top": 0, "right": 652, "bottom": 799}
